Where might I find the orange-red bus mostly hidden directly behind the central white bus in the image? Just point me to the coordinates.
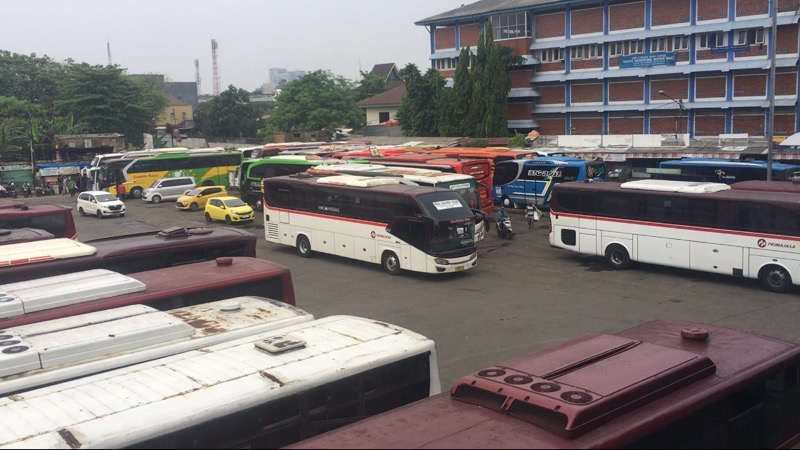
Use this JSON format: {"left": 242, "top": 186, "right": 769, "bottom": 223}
{"left": 340, "top": 152, "right": 494, "bottom": 214}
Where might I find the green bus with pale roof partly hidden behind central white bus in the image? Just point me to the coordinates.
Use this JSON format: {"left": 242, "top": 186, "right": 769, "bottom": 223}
{"left": 236, "top": 155, "right": 368, "bottom": 211}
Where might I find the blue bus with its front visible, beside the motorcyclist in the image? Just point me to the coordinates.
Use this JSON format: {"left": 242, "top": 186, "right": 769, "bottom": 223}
{"left": 492, "top": 156, "right": 606, "bottom": 208}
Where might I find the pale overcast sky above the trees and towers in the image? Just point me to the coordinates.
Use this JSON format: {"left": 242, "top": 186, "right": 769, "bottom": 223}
{"left": 0, "top": 0, "right": 466, "bottom": 94}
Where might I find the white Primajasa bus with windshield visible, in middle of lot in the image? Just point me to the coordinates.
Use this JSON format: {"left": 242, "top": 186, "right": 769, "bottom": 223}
{"left": 262, "top": 173, "right": 481, "bottom": 275}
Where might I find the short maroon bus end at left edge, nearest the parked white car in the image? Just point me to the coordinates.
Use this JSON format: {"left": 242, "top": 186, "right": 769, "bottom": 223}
{"left": 0, "top": 201, "right": 78, "bottom": 239}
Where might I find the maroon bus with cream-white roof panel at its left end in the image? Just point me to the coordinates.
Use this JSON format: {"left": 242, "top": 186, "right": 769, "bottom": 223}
{"left": 0, "top": 227, "right": 257, "bottom": 283}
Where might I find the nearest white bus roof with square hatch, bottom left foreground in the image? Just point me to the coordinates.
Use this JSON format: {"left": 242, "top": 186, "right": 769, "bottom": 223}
{"left": 0, "top": 316, "right": 441, "bottom": 448}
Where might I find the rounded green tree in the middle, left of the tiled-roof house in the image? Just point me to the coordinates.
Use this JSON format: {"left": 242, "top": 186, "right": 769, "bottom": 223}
{"left": 259, "top": 70, "right": 366, "bottom": 138}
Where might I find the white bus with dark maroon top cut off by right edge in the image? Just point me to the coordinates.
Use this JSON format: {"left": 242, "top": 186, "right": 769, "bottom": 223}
{"left": 550, "top": 180, "right": 800, "bottom": 292}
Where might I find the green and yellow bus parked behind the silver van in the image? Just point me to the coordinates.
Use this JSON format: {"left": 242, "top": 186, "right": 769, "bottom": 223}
{"left": 100, "top": 149, "right": 242, "bottom": 198}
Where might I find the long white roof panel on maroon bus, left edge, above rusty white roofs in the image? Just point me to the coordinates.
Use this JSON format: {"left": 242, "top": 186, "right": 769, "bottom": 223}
{"left": 0, "top": 269, "right": 147, "bottom": 319}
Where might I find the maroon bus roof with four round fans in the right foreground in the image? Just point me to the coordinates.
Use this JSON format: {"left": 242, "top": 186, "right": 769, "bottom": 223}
{"left": 293, "top": 321, "right": 800, "bottom": 448}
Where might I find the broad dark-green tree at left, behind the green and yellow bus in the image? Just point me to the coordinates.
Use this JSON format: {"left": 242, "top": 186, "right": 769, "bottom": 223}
{"left": 55, "top": 63, "right": 169, "bottom": 147}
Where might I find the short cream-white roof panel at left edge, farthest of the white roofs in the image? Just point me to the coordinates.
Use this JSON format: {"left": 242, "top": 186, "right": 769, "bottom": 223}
{"left": 0, "top": 238, "right": 97, "bottom": 267}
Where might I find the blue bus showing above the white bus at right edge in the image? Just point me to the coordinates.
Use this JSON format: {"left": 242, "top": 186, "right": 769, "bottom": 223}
{"left": 657, "top": 158, "right": 800, "bottom": 184}
